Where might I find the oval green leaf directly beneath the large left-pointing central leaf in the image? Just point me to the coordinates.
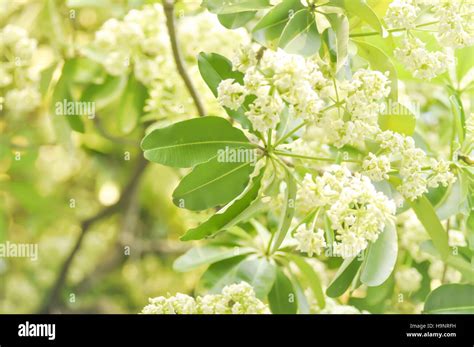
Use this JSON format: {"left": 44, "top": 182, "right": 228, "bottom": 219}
{"left": 173, "top": 156, "right": 253, "bottom": 211}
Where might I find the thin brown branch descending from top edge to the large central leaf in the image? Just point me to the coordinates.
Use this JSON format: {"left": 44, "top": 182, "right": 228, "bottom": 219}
{"left": 163, "top": 0, "right": 206, "bottom": 117}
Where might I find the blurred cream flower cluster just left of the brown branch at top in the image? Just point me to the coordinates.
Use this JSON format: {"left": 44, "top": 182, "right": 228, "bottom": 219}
{"left": 94, "top": 5, "right": 168, "bottom": 85}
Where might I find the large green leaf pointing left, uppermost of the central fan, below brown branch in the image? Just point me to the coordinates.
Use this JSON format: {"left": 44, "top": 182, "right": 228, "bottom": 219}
{"left": 141, "top": 116, "right": 255, "bottom": 167}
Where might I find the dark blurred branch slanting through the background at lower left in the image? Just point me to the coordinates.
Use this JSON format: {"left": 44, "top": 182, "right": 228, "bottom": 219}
{"left": 39, "top": 156, "right": 148, "bottom": 313}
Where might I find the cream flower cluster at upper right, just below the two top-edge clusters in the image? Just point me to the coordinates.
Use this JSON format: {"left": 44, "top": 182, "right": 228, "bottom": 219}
{"left": 394, "top": 36, "right": 454, "bottom": 80}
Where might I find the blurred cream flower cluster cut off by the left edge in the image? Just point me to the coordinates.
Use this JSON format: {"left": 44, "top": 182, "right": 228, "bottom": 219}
{"left": 0, "top": 25, "right": 40, "bottom": 113}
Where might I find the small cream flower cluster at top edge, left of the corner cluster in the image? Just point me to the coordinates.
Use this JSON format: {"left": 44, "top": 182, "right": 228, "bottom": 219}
{"left": 385, "top": 0, "right": 420, "bottom": 29}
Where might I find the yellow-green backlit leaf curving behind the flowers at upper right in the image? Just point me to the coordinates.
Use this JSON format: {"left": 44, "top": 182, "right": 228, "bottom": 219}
{"left": 352, "top": 40, "right": 398, "bottom": 101}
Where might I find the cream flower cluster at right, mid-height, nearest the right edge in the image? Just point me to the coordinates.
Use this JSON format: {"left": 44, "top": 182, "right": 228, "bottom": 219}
{"left": 374, "top": 130, "right": 455, "bottom": 200}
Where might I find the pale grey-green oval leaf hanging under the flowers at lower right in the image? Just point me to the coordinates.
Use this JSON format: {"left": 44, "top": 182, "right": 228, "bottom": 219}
{"left": 360, "top": 225, "right": 398, "bottom": 287}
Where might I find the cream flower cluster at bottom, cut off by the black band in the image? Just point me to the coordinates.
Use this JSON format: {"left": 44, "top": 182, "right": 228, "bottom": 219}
{"left": 142, "top": 282, "right": 269, "bottom": 314}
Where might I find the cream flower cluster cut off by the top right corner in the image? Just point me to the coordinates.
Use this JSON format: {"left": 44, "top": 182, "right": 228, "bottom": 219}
{"left": 435, "top": 0, "right": 474, "bottom": 48}
